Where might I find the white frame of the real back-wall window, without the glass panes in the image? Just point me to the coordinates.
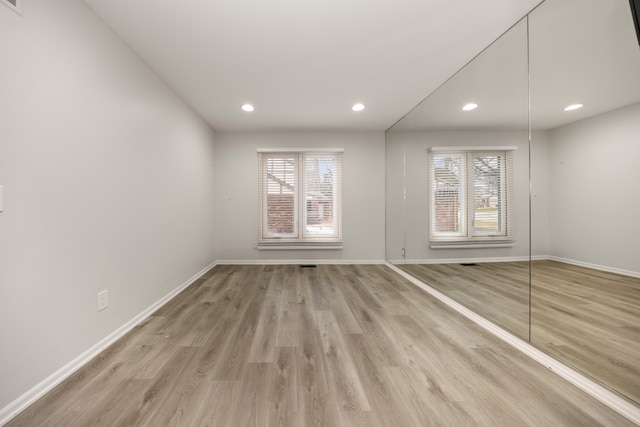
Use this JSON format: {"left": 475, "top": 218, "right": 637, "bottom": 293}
{"left": 257, "top": 148, "right": 344, "bottom": 249}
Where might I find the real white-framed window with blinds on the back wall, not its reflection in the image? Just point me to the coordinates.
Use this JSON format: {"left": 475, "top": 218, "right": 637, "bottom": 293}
{"left": 258, "top": 149, "right": 342, "bottom": 249}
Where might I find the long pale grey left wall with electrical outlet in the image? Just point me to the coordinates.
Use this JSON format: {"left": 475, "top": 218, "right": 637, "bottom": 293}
{"left": 0, "top": 0, "right": 216, "bottom": 410}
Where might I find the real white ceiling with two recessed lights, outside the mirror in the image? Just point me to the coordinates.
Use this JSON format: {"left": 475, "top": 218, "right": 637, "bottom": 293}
{"left": 84, "top": 0, "right": 540, "bottom": 131}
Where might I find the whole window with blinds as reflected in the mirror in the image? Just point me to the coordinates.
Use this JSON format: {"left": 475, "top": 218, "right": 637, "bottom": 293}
{"left": 429, "top": 147, "right": 515, "bottom": 248}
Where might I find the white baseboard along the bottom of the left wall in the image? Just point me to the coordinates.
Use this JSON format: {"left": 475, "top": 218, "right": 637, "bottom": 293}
{"left": 0, "top": 262, "right": 216, "bottom": 426}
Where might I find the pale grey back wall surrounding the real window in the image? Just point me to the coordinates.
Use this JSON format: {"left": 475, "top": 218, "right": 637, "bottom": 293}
{"left": 215, "top": 132, "right": 385, "bottom": 262}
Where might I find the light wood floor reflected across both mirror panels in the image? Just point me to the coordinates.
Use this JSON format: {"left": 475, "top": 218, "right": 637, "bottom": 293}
{"left": 403, "top": 261, "right": 640, "bottom": 404}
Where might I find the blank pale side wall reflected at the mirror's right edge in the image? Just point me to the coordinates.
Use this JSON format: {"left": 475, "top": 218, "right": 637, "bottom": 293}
{"left": 549, "top": 103, "right": 640, "bottom": 273}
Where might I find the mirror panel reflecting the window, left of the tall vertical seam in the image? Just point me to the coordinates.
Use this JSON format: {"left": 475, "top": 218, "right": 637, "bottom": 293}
{"left": 387, "top": 20, "right": 529, "bottom": 339}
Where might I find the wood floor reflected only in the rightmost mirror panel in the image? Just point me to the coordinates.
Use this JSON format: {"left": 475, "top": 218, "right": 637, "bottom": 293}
{"left": 531, "top": 261, "right": 640, "bottom": 408}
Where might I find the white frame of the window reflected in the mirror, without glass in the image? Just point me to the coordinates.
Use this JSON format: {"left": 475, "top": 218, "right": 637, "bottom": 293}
{"left": 428, "top": 146, "right": 517, "bottom": 249}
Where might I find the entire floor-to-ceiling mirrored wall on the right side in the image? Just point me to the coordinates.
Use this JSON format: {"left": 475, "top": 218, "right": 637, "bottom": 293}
{"left": 386, "top": 0, "right": 640, "bottom": 402}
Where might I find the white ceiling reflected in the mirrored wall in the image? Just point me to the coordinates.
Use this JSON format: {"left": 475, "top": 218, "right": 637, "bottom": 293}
{"left": 394, "top": 0, "right": 640, "bottom": 131}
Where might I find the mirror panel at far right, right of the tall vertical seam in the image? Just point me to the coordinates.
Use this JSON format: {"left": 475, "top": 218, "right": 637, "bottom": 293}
{"left": 529, "top": 0, "right": 640, "bottom": 402}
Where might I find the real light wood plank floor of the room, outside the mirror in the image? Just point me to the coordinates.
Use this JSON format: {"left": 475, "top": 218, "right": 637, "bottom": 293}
{"left": 8, "top": 265, "right": 632, "bottom": 427}
